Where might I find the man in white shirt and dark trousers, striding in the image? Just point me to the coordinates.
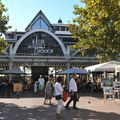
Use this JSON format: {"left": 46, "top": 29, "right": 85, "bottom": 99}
{"left": 65, "top": 74, "right": 78, "bottom": 110}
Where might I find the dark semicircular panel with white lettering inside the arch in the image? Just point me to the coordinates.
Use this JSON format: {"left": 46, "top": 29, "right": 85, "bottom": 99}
{"left": 17, "top": 32, "right": 63, "bottom": 56}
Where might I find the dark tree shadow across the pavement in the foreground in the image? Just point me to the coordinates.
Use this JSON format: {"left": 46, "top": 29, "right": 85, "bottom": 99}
{"left": 0, "top": 103, "right": 120, "bottom": 120}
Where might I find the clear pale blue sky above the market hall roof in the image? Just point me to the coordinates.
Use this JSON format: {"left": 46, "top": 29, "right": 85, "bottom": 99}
{"left": 2, "top": 0, "right": 83, "bottom": 31}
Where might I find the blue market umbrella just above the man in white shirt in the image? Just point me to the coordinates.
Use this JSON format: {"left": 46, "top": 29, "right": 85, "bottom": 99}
{"left": 56, "top": 68, "right": 88, "bottom": 75}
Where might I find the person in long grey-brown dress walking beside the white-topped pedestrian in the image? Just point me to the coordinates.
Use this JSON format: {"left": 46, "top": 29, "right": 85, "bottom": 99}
{"left": 44, "top": 78, "right": 52, "bottom": 105}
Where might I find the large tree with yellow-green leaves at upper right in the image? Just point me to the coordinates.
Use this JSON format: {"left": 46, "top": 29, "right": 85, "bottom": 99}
{"left": 69, "top": 0, "right": 120, "bottom": 62}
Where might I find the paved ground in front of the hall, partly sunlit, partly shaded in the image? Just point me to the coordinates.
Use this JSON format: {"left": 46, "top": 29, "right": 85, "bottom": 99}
{"left": 0, "top": 96, "right": 120, "bottom": 120}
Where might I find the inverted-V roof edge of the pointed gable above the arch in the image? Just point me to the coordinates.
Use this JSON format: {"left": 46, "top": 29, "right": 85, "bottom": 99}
{"left": 25, "top": 10, "right": 51, "bottom": 30}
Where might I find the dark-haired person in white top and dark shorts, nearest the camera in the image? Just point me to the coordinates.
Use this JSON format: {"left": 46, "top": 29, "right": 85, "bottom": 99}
{"left": 54, "top": 76, "right": 63, "bottom": 119}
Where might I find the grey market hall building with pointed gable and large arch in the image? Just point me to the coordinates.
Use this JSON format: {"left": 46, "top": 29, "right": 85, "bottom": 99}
{"left": 0, "top": 10, "right": 98, "bottom": 80}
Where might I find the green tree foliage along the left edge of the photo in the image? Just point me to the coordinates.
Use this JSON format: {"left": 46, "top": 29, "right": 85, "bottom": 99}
{"left": 0, "top": 0, "right": 10, "bottom": 53}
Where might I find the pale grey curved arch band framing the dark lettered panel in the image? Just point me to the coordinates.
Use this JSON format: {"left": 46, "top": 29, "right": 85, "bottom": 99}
{"left": 12, "top": 29, "right": 68, "bottom": 55}
